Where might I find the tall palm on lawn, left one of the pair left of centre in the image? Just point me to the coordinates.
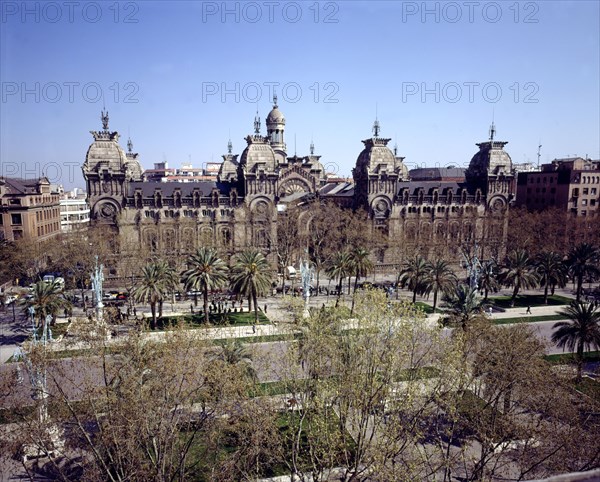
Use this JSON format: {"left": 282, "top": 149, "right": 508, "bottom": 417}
{"left": 182, "top": 247, "right": 228, "bottom": 323}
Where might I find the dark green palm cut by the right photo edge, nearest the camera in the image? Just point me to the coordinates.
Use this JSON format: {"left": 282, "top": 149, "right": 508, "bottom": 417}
{"left": 552, "top": 301, "right": 600, "bottom": 381}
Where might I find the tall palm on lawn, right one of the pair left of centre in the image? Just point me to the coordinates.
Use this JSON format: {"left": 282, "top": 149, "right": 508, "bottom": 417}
{"left": 231, "top": 248, "right": 271, "bottom": 323}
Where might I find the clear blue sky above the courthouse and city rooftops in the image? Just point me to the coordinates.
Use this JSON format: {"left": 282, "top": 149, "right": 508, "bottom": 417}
{"left": 0, "top": 0, "right": 600, "bottom": 188}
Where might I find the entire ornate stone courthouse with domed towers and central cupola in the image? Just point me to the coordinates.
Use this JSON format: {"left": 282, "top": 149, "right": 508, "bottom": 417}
{"left": 83, "top": 97, "right": 515, "bottom": 272}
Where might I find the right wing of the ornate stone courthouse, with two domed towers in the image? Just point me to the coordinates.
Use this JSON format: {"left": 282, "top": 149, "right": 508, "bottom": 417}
{"left": 353, "top": 123, "right": 515, "bottom": 262}
